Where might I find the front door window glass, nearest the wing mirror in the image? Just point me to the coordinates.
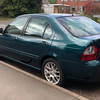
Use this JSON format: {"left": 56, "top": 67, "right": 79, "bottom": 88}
{"left": 5, "top": 17, "right": 28, "bottom": 34}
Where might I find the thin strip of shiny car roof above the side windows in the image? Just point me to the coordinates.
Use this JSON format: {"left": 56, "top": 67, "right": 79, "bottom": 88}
{"left": 18, "top": 13, "right": 77, "bottom": 18}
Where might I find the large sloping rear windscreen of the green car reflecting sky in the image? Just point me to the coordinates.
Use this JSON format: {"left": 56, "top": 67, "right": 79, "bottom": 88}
{"left": 57, "top": 16, "right": 100, "bottom": 37}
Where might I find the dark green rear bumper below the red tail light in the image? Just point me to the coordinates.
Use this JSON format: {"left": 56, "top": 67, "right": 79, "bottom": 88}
{"left": 59, "top": 60, "right": 100, "bottom": 82}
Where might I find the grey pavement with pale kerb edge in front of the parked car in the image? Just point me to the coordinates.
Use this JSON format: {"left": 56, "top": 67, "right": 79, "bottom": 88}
{"left": 0, "top": 58, "right": 88, "bottom": 100}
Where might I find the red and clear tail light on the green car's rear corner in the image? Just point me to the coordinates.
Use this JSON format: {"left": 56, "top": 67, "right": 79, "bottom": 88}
{"left": 81, "top": 46, "right": 97, "bottom": 61}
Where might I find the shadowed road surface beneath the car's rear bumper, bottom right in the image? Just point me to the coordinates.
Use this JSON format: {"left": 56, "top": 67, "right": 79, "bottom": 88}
{"left": 65, "top": 79, "right": 100, "bottom": 100}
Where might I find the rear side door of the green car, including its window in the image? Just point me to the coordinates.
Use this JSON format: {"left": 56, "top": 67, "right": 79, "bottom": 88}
{"left": 19, "top": 17, "right": 52, "bottom": 67}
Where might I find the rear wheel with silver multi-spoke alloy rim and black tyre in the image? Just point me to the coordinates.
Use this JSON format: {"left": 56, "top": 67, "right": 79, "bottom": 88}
{"left": 42, "top": 58, "right": 65, "bottom": 86}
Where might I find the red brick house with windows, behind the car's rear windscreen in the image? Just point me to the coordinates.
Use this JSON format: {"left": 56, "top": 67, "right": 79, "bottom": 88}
{"left": 57, "top": 0, "right": 93, "bottom": 12}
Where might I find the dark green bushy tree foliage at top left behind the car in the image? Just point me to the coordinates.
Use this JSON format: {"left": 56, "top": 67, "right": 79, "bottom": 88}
{"left": 0, "top": 0, "right": 42, "bottom": 17}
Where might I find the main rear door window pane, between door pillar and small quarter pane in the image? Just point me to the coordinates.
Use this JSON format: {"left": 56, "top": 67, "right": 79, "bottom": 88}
{"left": 25, "top": 18, "right": 47, "bottom": 37}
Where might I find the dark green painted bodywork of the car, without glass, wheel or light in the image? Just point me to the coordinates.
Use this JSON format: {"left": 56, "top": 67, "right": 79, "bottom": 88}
{"left": 0, "top": 14, "right": 100, "bottom": 81}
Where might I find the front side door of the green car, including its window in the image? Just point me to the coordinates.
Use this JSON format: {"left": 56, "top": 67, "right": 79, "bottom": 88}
{"left": 0, "top": 17, "right": 28, "bottom": 59}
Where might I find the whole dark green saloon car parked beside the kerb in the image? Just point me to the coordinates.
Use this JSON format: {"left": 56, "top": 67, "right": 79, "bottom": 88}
{"left": 0, "top": 14, "right": 100, "bottom": 85}
